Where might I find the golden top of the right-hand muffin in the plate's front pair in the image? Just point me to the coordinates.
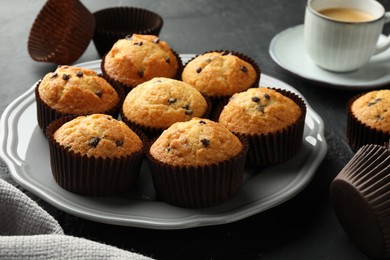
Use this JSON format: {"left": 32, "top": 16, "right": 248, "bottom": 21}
{"left": 150, "top": 118, "right": 243, "bottom": 166}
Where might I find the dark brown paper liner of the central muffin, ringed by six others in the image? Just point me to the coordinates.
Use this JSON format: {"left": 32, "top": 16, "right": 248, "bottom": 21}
{"left": 120, "top": 97, "right": 212, "bottom": 139}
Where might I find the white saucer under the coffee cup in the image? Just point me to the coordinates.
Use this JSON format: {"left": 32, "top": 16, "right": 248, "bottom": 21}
{"left": 269, "top": 25, "right": 390, "bottom": 90}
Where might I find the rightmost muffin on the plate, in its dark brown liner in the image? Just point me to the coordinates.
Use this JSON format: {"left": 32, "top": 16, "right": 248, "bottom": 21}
{"left": 218, "top": 87, "right": 306, "bottom": 167}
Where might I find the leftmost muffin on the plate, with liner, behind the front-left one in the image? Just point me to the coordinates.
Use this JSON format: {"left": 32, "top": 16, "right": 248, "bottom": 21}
{"left": 35, "top": 66, "right": 121, "bottom": 132}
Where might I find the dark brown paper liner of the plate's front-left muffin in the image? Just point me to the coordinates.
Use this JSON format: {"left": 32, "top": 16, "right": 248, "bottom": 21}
{"left": 47, "top": 117, "right": 146, "bottom": 196}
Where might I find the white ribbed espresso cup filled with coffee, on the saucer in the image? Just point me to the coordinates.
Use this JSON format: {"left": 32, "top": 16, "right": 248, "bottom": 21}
{"left": 304, "top": 0, "right": 390, "bottom": 72}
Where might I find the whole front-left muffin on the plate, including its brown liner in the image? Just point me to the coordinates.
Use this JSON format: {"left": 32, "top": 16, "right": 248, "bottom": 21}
{"left": 47, "top": 114, "right": 145, "bottom": 196}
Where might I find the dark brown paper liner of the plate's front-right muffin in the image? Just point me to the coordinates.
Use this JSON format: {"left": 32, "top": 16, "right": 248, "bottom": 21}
{"left": 146, "top": 136, "right": 248, "bottom": 208}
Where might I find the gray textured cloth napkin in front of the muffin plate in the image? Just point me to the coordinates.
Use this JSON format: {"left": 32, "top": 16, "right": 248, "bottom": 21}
{"left": 0, "top": 179, "right": 151, "bottom": 260}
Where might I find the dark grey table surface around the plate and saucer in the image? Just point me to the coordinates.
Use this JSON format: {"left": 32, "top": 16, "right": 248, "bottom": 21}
{"left": 0, "top": 0, "right": 390, "bottom": 260}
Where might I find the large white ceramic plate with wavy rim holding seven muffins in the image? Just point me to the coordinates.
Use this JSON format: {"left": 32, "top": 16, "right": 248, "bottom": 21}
{"left": 0, "top": 55, "right": 327, "bottom": 229}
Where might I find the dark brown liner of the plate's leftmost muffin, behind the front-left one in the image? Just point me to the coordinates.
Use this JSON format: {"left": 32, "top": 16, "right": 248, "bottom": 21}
{"left": 35, "top": 82, "right": 124, "bottom": 135}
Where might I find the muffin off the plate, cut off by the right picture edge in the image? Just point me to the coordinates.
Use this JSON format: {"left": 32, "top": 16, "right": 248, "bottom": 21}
{"left": 347, "top": 89, "right": 390, "bottom": 152}
